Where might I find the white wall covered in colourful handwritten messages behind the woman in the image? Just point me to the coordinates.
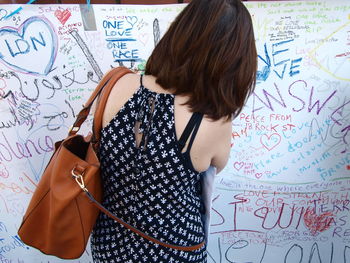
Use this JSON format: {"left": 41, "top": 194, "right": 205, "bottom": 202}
{"left": 0, "top": 0, "right": 350, "bottom": 263}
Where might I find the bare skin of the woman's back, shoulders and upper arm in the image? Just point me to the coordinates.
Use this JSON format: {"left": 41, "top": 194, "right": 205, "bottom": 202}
{"left": 103, "top": 74, "right": 231, "bottom": 172}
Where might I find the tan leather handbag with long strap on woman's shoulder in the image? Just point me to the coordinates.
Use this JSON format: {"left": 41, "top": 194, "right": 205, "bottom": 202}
{"left": 18, "top": 68, "right": 204, "bottom": 259}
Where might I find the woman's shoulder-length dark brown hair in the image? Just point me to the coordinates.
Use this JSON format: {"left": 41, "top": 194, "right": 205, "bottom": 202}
{"left": 145, "top": 0, "right": 257, "bottom": 120}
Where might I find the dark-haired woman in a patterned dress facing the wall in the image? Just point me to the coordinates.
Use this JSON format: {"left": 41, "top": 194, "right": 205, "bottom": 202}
{"left": 91, "top": 0, "right": 257, "bottom": 263}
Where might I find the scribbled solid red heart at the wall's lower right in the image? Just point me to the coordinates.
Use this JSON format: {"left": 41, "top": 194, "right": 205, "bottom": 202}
{"left": 304, "top": 208, "right": 333, "bottom": 236}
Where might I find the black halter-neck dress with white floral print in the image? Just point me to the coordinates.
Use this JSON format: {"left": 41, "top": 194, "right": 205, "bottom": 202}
{"left": 91, "top": 78, "right": 207, "bottom": 263}
